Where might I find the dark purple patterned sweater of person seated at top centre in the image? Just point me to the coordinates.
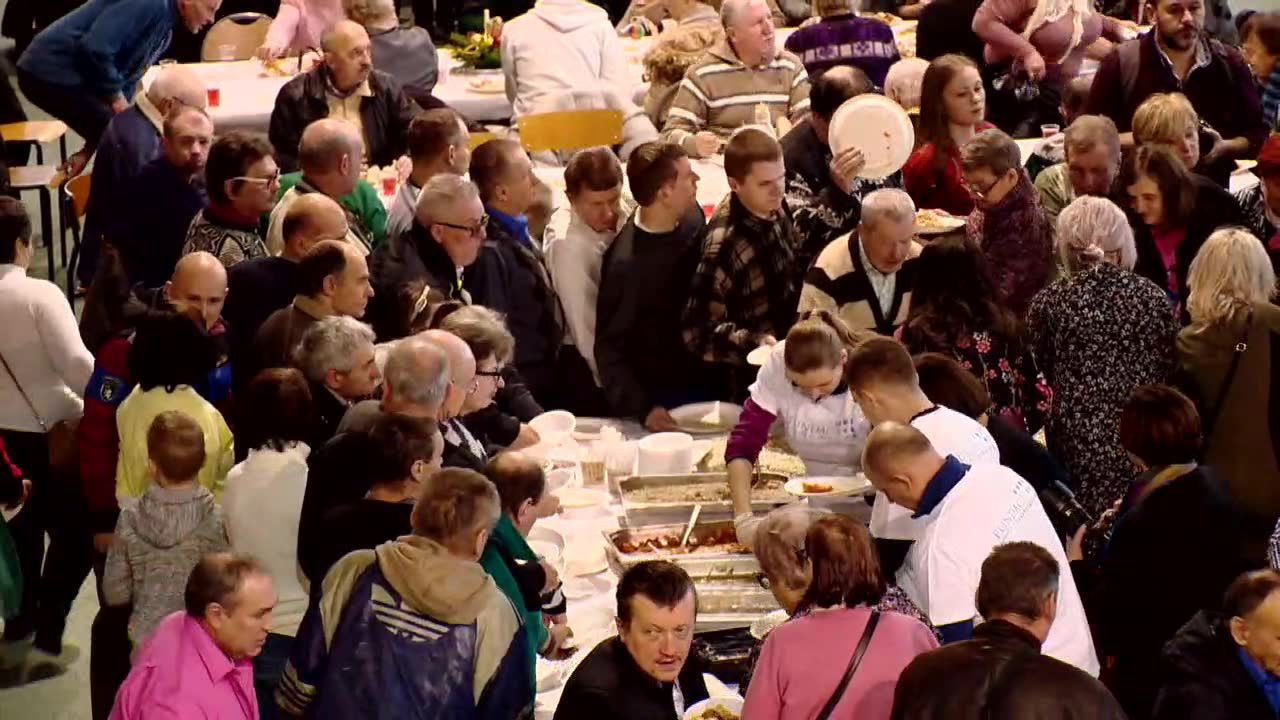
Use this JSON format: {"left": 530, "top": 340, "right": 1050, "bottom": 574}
{"left": 787, "top": 15, "right": 899, "bottom": 87}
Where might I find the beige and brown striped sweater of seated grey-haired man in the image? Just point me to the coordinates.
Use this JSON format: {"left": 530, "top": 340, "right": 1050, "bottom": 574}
{"left": 663, "top": 41, "right": 809, "bottom": 154}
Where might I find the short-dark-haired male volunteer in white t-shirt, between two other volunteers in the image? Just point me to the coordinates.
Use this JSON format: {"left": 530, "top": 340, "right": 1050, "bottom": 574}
{"left": 845, "top": 337, "right": 1000, "bottom": 541}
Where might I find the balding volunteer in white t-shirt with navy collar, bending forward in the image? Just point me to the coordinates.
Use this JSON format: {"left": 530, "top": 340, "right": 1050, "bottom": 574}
{"left": 863, "top": 421, "right": 1098, "bottom": 676}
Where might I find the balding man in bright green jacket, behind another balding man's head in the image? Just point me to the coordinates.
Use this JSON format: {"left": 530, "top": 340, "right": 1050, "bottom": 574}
{"left": 266, "top": 118, "right": 387, "bottom": 255}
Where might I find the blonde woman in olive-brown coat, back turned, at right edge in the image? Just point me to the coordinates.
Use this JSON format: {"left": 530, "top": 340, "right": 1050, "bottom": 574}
{"left": 1178, "top": 227, "right": 1280, "bottom": 547}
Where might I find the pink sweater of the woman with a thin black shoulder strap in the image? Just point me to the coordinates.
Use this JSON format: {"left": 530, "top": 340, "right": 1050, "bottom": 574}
{"left": 742, "top": 607, "right": 938, "bottom": 720}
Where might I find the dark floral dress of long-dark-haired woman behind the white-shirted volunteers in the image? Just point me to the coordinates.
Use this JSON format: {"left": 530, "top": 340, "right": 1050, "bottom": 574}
{"left": 902, "top": 325, "right": 1053, "bottom": 434}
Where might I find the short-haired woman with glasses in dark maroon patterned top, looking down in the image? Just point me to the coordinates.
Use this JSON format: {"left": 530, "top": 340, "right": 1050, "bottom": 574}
{"left": 960, "top": 129, "right": 1053, "bottom": 316}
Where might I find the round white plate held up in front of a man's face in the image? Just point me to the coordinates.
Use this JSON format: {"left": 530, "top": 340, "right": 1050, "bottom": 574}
{"left": 828, "top": 94, "right": 915, "bottom": 179}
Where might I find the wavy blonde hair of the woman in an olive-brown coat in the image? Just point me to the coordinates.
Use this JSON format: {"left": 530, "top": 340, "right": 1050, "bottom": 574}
{"left": 1187, "top": 228, "right": 1276, "bottom": 325}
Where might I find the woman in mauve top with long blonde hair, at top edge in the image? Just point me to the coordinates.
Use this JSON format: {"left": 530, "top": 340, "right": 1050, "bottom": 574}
{"left": 973, "top": 0, "right": 1124, "bottom": 87}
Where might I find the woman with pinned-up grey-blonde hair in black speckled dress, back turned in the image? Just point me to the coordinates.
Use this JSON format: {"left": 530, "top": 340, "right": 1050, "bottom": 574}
{"left": 1027, "top": 197, "right": 1178, "bottom": 518}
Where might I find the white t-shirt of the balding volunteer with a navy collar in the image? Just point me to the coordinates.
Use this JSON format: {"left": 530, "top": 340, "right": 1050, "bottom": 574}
{"left": 897, "top": 464, "right": 1098, "bottom": 676}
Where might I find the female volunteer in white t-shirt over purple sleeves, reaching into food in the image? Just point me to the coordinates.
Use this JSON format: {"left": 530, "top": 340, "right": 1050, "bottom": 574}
{"left": 724, "top": 310, "right": 870, "bottom": 544}
